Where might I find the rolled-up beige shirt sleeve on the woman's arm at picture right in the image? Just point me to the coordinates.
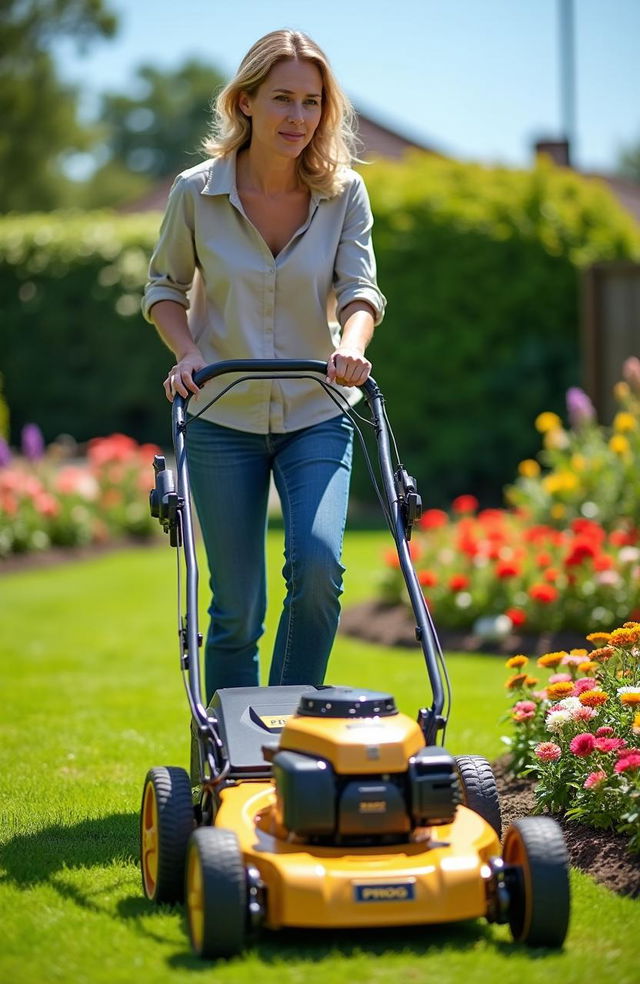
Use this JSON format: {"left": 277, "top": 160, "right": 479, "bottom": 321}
{"left": 333, "top": 174, "right": 387, "bottom": 325}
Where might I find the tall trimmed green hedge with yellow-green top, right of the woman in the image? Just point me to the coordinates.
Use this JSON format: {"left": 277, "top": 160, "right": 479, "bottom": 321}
{"left": 365, "top": 155, "right": 640, "bottom": 506}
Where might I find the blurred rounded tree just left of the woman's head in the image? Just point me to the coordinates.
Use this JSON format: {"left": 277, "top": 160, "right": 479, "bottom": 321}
{"left": 83, "top": 59, "right": 224, "bottom": 207}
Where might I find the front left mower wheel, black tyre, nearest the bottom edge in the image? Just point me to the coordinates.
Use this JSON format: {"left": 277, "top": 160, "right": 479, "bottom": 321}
{"left": 185, "top": 827, "right": 249, "bottom": 959}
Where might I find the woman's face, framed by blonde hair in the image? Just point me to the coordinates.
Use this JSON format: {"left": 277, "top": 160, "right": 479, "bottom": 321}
{"left": 239, "top": 58, "right": 322, "bottom": 159}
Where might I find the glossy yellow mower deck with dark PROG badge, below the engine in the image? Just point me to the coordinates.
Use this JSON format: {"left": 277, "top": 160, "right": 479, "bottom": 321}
{"left": 215, "top": 782, "right": 500, "bottom": 929}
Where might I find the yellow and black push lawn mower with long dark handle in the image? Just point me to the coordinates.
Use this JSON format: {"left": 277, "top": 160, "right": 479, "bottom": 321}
{"left": 140, "top": 360, "right": 570, "bottom": 958}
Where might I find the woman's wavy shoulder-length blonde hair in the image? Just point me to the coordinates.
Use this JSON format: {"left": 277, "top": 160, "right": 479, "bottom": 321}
{"left": 202, "top": 30, "right": 357, "bottom": 196}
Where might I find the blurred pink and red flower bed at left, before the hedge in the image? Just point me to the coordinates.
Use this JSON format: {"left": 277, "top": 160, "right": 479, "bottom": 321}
{"left": 0, "top": 425, "right": 159, "bottom": 558}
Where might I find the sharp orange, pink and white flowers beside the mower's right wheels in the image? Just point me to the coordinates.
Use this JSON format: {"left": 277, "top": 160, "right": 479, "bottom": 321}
{"left": 505, "top": 622, "right": 640, "bottom": 852}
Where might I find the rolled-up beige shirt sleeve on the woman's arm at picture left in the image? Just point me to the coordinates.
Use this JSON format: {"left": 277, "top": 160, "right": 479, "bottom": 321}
{"left": 142, "top": 176, "right": 196, "bottom": 321}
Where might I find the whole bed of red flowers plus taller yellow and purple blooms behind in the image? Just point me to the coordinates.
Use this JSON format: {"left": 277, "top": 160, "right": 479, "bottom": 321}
{"left": 381, "top": 358, "right": 640, "bottom": 641}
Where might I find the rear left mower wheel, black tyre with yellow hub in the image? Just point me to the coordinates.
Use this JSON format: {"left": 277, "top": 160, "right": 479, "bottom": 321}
{"left": 140, "top": 766, "right": 194, "bottom": 903}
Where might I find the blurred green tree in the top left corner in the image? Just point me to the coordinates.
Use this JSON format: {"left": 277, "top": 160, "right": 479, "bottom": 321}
{"left": 0, "top": 0, "right": 117, "bottom": 212}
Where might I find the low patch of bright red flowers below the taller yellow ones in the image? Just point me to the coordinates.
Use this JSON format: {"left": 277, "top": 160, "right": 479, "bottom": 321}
{"left": 381, "top": 504, "right": 640, "bottom": 639}
